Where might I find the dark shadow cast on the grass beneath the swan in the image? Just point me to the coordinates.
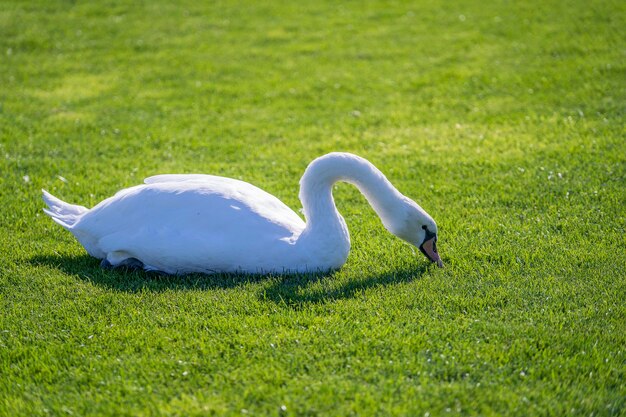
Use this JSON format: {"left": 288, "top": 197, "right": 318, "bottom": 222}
{"left": 30, "top": 254, "right": 428, "bottom": 306}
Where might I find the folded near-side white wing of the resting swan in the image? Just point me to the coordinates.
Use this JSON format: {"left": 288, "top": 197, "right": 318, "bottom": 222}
{"left": 77, "top": 181, "right": 305, "bottom": 272}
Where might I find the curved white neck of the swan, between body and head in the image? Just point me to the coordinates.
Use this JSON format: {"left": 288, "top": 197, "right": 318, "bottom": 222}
{"left": 300, "top": 153, "right": 404, "bottom": 240}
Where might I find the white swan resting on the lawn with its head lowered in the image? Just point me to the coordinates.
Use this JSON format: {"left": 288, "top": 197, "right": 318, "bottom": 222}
{"left": 43, "top": 153, "right": 443, "bottom": 274}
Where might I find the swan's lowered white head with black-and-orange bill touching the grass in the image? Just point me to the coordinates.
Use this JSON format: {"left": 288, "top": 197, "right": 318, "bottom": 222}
{"left": 387, "top": 198, "right": 443, "bottom": 267}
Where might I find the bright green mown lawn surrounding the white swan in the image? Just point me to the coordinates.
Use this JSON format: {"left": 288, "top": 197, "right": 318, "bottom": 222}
{"left": 0, "top": 0, "right": 626, "bottom": 416}
